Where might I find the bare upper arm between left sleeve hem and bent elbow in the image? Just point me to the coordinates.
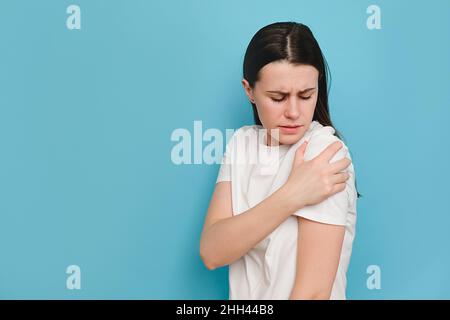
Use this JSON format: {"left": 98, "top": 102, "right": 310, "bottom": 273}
{"left": 203, "top": 181, "right": 233, "bottom": 230}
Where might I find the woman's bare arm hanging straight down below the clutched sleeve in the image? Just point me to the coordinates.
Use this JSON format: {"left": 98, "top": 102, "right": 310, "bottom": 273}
{"left": 291, "top": 217, "right": 345, "bottom": 299}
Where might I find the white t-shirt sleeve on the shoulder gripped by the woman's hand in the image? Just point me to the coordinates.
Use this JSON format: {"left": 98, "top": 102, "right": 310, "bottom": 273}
{"left": 294, "top": 135, "right": 353, "bottom": 225}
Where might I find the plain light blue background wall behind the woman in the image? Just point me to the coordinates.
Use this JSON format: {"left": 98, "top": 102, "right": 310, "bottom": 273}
{"left": 0, "top": 0, "right": 450, "bottom": 299}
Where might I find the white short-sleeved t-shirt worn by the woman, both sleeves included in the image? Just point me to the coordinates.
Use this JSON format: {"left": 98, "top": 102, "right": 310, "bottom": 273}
{"left": 216, "top": 121, "right": 357, "bottom": 300}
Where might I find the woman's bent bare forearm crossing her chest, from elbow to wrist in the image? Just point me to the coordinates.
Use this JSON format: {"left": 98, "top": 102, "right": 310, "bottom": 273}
{"left": 200, "top": 186, "right": 300, "bottom": 270}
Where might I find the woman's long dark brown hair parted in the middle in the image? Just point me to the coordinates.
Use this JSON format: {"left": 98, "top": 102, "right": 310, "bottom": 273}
{"left": 243, "top": 22, "right": 361, "bottom": 198}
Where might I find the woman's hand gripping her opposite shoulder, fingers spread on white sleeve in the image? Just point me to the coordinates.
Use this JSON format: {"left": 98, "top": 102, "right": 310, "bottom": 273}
{"left": 283, "top": 141, "right": 351, "bottom": 211}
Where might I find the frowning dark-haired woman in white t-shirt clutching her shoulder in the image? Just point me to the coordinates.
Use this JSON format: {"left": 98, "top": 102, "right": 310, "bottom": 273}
{"left": 200, "top": 22, "right": 359, "bottom": 299}
